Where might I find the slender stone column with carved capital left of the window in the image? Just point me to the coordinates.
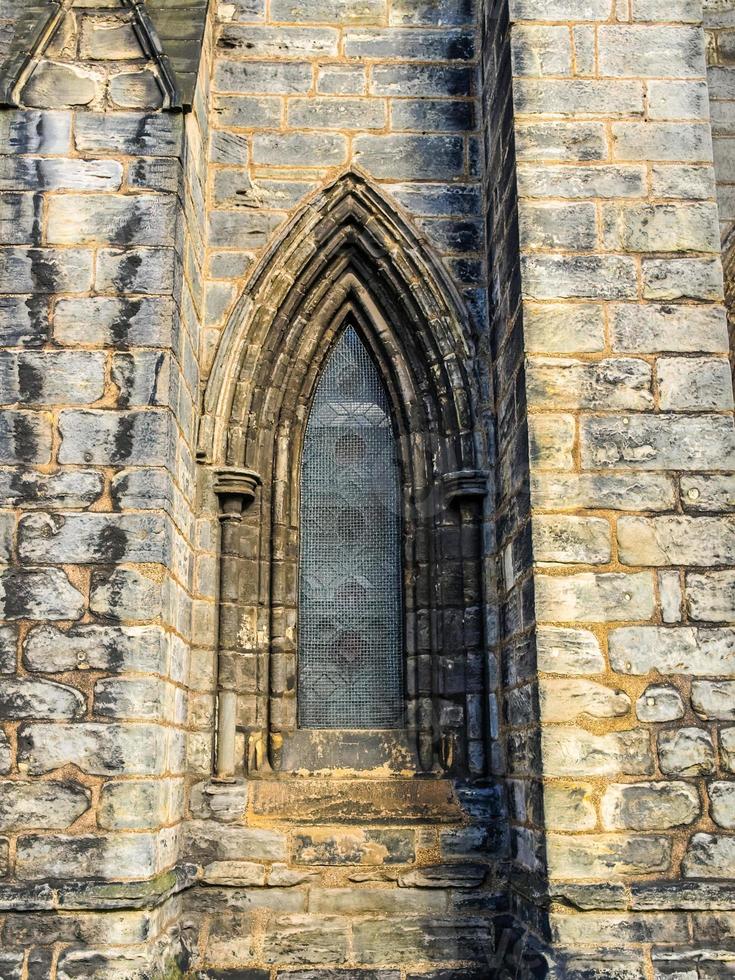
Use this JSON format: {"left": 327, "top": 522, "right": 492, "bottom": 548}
{"left": 214, "top": 466, "right": 262, "bottom": 782}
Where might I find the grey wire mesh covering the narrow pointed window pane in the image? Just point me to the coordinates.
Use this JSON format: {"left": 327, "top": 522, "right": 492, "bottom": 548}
{"left": 299, "top": 327, "right": 403, "bottom": 728}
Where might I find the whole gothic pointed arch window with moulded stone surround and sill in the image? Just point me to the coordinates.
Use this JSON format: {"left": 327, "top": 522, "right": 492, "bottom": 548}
{"left": 200, "top": 174, "right": 495, "bottom": 778}
